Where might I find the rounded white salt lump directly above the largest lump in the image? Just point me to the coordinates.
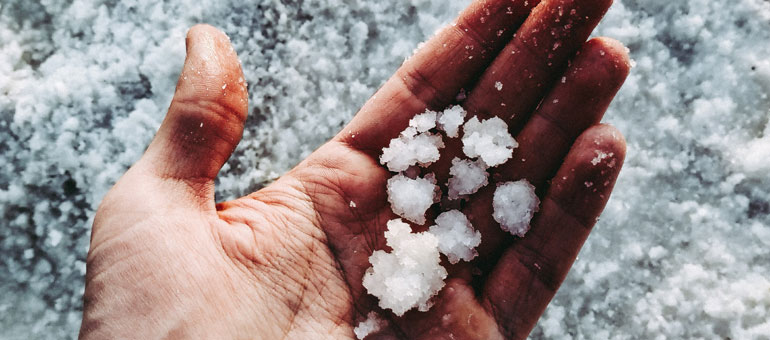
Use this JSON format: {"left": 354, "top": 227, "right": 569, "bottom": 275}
{"left": 388, "top": 174, "right": 440, "bottom": 224}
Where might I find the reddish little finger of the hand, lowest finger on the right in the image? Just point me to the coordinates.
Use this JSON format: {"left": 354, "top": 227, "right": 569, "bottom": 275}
{"left": 482, "top": 125, "right": 626, "bottom": 339}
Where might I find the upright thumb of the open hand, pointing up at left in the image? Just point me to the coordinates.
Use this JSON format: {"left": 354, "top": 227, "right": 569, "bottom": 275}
{"left": 140, "top": 25, "right": 248, "bottom": 196}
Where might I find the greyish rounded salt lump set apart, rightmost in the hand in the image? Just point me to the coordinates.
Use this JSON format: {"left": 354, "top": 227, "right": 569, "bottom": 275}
{"left": 492, "top": 179, "right": 540, "bottom": 237}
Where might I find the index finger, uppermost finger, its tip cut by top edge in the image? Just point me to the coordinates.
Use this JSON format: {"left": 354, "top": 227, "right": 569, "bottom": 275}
{"left": 335, "top": 0, "right": 540, "bottom": 156}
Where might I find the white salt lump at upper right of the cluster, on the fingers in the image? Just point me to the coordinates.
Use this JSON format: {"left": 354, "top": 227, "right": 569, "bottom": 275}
{"left": 463, "top": 116, "right": 519, "bottom": 167}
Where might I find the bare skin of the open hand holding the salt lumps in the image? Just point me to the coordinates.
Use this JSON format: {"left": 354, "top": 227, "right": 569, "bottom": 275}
{"left": 80, "top": 0, "right": 630, "bottom": 339}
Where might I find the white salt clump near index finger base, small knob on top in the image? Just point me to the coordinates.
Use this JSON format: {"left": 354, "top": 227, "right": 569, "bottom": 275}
{"left": 380, "top": 111, "right": 444, "bottom": 172}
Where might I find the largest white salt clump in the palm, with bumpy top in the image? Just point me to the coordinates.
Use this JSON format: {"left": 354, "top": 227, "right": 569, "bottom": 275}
{"left": 363, "top": 219, "right": 447, "bottom": 316}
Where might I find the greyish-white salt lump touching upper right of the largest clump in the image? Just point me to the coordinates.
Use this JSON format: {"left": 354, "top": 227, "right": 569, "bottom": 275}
{"left": 428, "top": 210, "right": 481, "bottom": 264}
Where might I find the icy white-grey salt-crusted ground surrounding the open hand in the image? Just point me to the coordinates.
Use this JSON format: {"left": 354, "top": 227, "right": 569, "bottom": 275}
{"left": 0, "top": 0, "right": 770, "bottom": 339}
